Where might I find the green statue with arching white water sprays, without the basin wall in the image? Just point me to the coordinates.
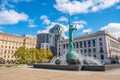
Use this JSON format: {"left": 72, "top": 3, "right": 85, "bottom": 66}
{"left": 51, "top": 21, "right": 102, "bottom": 65}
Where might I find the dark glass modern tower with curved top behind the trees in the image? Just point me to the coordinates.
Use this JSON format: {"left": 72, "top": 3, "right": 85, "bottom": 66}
{"left": 37, "top": 24, "right": 64, "bottom": 55}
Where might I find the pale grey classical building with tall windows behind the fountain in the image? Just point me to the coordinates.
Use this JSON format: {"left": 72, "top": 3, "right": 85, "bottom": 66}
{"left": 57, "top": 31, "right": 120, "bottom": 64}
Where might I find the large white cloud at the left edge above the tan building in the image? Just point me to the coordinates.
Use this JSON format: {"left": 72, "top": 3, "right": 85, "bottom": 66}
{"left": 0, "top": 10, "right": 29, "bottom": 25}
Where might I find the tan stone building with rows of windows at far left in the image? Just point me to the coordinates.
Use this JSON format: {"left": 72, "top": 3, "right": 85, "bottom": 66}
{"left": 0, "top": 33, "right": 36, "bottom": 63}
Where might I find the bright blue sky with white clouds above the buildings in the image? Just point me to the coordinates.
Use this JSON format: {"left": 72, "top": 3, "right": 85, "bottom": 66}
{"left": 0, "top": 0, "right": 120, "bottom": 38}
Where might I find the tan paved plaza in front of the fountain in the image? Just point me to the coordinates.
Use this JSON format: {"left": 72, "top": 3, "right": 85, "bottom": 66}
{"left": 0, "top": 67, "right": 120, "bottom": 80}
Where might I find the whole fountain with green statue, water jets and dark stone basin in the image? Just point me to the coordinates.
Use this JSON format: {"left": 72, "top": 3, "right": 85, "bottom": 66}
{"left": 33, "top": 21, "right": 120, "bottom": 71}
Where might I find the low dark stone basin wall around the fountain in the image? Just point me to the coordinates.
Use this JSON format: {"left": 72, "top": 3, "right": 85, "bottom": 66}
{"left": 33, "top": 63, "right": 120, "bottom": 71}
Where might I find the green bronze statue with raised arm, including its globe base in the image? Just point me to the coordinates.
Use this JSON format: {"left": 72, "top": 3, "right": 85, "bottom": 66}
{"left": 66, "top": 21, "right": 80, "bottom": 65}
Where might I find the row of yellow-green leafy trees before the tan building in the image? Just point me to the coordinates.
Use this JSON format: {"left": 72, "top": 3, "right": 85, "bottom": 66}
{"left": 15, "top": 46, "right": 53, "bottom": 64}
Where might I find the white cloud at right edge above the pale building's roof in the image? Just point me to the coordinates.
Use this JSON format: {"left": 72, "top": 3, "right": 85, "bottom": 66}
{"left": 100, "top": 23, "right": 120, "bottom": 38}
